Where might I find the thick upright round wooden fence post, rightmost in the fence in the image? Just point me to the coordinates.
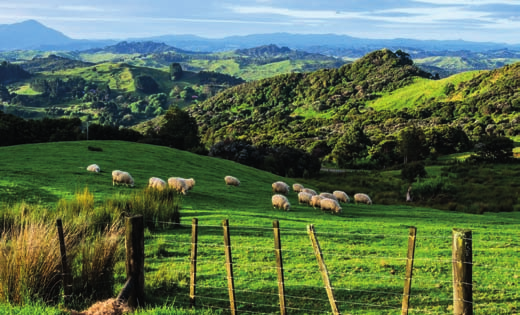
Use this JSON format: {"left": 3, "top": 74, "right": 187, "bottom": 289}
{"left": 452, "top": 229, "right": 473, "bottom": 315}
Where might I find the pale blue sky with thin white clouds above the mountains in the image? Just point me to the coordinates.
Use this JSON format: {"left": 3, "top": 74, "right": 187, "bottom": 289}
{"left": 0, "top": 0, "right": 520, "bottom": 44}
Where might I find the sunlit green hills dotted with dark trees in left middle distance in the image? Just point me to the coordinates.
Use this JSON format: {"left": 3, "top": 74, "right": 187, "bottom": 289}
{"left": 2, "top": 60, "right": 243, "bottom": 127}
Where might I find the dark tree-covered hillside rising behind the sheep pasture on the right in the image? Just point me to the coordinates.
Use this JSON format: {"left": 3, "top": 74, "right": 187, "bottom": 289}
{"left": 190, "top": 50, "right": 520, "bottom": 167}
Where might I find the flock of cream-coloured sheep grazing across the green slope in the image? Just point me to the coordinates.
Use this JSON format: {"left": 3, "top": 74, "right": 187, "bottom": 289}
{"left": 87, "top": 164, "right": 372, "bottom": 213}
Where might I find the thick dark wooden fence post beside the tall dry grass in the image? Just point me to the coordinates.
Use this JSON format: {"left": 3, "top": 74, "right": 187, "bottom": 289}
{"left": 118, "top": 215, "right": 144, "bottom": 307}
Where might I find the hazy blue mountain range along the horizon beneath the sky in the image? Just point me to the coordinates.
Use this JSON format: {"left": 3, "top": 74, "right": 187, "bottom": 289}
{"left": 0, "top": 20, "right": 520, "bottom": 57}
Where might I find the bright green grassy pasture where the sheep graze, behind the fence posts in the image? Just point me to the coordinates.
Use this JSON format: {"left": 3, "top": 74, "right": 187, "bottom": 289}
{"left": 0, "top": 141, "right": 520, "bottom": 314}
